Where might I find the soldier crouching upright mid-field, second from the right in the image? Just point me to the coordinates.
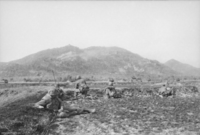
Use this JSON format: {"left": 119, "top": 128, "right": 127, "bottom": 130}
{"left": 105, "top": 79, "right": 115, "bottom": 98}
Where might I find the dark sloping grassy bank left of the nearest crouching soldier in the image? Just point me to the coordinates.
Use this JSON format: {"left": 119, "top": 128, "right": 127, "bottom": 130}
{"left": 0, "top": 87, "right": 53, "bottom": 135}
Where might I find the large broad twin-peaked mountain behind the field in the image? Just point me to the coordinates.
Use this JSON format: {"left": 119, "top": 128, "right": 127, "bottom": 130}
{"left": 0, "top": 45, "right": 178, "bottom": 78}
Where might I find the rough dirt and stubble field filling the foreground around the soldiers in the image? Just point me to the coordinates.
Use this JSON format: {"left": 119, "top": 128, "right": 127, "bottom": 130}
{"left": 0, "top": 82, "right": 200, "bottom": 135}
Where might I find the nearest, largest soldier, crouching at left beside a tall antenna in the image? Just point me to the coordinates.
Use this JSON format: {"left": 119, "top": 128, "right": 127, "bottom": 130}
{"left": 35, "top": 84, "right": 64, "bottom": 111}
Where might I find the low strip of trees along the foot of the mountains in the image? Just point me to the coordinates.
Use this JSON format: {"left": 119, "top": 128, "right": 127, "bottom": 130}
{"left": 0, "top": 73, "right": 200, "bottom": 83}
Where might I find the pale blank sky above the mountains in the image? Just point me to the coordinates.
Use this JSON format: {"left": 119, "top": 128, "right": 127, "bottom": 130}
{"left": 0, "top": 1, "right": 200, "bottom": 67}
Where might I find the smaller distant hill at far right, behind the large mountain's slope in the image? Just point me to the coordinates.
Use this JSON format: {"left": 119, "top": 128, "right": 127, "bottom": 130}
{"left": 165, "top": 59, "right": 200, "bottom": 76}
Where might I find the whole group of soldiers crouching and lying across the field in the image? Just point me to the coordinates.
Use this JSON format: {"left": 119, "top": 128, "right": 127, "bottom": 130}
{"left": 34, "top": 76, "right": 174, "bottom": 117}
